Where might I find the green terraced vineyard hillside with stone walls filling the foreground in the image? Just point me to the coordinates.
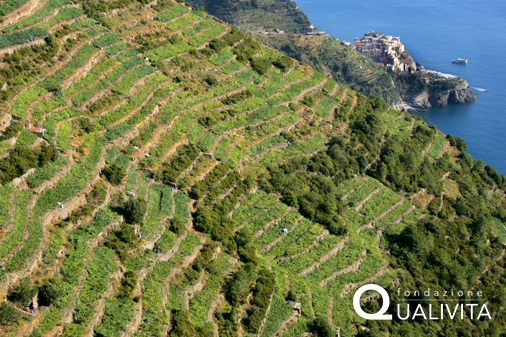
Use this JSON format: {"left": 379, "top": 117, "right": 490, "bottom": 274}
{"left": 0, "top": 0, "right": 506, "bottom": 336}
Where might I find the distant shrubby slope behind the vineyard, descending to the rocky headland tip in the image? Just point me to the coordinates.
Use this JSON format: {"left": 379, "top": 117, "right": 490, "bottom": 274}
{"left": 189, "top": 0, "right": 476, "bottom": 107}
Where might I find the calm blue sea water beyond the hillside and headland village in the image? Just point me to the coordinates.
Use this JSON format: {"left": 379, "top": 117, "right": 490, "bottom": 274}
{"left": 295, "top": 0, "right": 506, "bottom": 174}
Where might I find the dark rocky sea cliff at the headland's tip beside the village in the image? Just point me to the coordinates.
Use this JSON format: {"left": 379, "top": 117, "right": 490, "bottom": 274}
{"left": 404, "top": 80, "right": 476, "bottom": 109}
